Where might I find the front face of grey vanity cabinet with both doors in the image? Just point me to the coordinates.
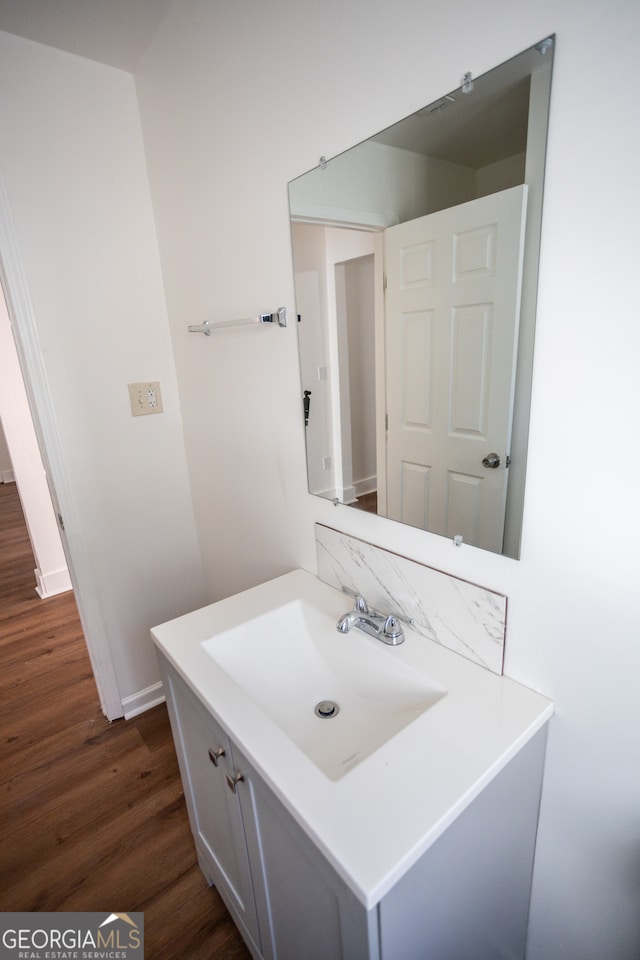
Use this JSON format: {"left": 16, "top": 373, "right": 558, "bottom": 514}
{"left": 161, "top": 658, "right": 378, "bottom": 960}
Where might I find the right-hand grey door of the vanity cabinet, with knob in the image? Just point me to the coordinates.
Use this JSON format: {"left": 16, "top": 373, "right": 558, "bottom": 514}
{"left": 232, "top": 744, "right": 379, "bottom": 960}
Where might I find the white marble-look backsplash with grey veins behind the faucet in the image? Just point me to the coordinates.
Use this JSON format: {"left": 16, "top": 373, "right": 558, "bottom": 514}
{"left": 316, "top": 523, "right": 507, "bottom": 673}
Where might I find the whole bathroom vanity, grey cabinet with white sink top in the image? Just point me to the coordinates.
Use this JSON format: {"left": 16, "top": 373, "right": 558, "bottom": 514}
{"left": 152, "top": 570, "right": 552, "bottom": 960}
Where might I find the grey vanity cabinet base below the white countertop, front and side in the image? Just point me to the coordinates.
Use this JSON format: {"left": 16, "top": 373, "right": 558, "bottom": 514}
{"left": 160, "top": 655, "right": 546, "bottom": 960}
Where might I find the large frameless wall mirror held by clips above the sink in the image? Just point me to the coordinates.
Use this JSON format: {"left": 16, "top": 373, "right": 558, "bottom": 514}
{"left": 289, "top": 38, "right": 554, "bottom": 558}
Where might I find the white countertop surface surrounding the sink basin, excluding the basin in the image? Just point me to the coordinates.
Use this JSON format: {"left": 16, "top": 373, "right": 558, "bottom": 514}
{"left": 152, "top": 570, "right": 553, "bottom": 908}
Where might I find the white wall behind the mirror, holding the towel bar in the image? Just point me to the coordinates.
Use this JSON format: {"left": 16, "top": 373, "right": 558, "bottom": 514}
{"left": 136, "top": 0, "right": 640, "bottom": 960}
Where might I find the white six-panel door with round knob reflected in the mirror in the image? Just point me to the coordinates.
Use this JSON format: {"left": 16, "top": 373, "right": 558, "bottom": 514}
{"left": 384, "top": 186, "right": 527, "bottom": 552}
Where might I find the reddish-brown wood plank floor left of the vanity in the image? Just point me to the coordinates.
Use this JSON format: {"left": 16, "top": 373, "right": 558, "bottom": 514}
{"left": 0, "top": 484, "right": 255, "bottom": 960}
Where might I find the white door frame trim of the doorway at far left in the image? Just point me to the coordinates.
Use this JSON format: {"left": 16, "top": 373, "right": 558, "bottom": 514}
{"left": 0, "top": 171, "right": 124, "bottom": 720}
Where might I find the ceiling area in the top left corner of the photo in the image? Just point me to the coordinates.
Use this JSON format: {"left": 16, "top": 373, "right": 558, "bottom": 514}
{"left": 0, "top": 0, "right": 174, "bottom": 73}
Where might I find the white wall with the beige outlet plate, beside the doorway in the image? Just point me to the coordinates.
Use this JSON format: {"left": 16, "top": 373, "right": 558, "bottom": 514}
{"left": 0, "top": 34, "right": 205, "bottom": 713}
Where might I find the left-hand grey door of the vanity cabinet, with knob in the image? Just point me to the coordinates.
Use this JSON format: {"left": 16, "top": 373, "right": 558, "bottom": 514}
{"left": 164, "top": 668, "right": 260, "bottom": 949}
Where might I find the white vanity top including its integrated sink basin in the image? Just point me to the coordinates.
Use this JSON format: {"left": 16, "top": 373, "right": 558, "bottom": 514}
{"left": 152, "top": 570, "right": 553, "bottom": 909}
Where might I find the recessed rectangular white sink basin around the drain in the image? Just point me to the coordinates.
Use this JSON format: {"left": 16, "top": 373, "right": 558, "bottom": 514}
{"left": 202, "top": 599, "right": 446, "bottom": 780}
